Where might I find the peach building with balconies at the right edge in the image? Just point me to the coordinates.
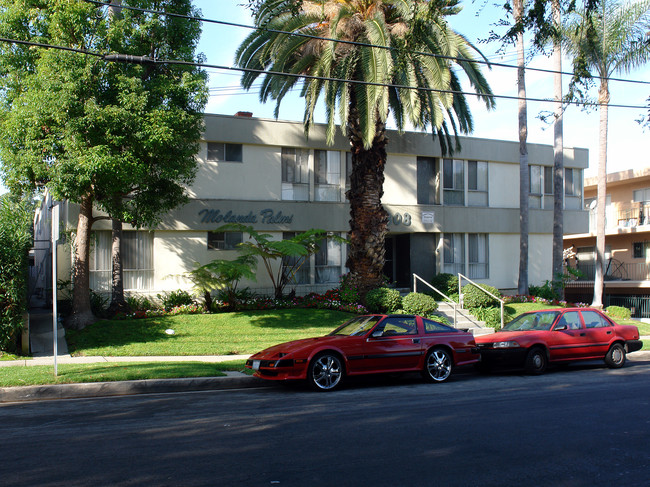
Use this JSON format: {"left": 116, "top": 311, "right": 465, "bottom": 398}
{"left": 564, "top": 169, "right": 650, "bottom": 318}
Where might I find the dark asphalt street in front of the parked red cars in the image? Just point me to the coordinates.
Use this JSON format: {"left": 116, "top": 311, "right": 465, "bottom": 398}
{"left": 0, "top": 360, "right": 650, "bottom": 487}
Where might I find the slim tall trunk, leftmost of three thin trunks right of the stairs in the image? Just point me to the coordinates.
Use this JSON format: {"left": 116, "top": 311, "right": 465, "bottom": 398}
{"left": 513, "top": 0, "right": 530, "bottom": 295}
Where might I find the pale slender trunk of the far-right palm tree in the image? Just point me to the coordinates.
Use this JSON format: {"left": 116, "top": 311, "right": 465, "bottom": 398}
{"left": 591, "top": 77, "right": 609, "bottom": 308}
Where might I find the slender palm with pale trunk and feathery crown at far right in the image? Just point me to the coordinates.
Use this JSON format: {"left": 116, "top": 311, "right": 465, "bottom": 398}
{"left": 565, "top": 0, "right": 650, "bottom": 307}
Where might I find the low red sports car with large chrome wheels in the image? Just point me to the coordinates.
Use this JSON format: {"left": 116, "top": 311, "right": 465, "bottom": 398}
{"left": 246, "top": 315, "right": 480, "bottom": 391}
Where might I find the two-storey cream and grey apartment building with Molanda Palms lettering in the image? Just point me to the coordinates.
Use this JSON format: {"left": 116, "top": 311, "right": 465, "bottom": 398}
{"left": 29, "top": 115, "right": 588, "bottom": 304}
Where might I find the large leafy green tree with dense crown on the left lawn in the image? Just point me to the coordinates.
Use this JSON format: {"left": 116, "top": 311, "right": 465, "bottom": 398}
{"left": 0, "top": 0, "right": 207, "bottom": 328}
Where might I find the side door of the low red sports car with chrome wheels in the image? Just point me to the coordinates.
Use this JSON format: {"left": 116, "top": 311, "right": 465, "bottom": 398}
{"left": 360, "top": 316, "right": 422, "bottom": 372}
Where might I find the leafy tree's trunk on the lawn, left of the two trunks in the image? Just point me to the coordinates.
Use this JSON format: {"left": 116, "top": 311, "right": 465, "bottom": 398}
{"left": 67, "top": 195, "right": 95, "bottom": 330}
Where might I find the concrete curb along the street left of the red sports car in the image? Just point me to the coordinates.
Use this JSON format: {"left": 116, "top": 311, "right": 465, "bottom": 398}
{"left": 0, "top": 372, "right": 269, "bottom": 403}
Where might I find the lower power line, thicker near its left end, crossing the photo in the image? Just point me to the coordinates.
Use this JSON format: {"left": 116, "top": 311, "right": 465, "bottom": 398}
{"left": 0, "top": 35, "right": 647, "bottom": 110}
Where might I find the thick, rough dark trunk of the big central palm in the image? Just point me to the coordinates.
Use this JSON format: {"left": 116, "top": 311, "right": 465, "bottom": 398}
{"left": 346, "top": 99, "right": 388, "bottom": 300}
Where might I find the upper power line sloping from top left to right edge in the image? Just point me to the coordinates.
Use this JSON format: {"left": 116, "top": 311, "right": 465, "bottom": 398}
{"left": 84, "top": 0, "right": 650, "bottom": 84}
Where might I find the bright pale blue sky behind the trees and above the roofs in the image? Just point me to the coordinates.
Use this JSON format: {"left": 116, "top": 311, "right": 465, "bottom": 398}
{"left": 194, "top": 0, "right": 650, "bottom": 177}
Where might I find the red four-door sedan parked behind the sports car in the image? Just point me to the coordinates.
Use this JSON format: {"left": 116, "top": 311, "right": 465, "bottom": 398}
{"left": 476, "top": 308, "right": 643, "bottom": 374}
